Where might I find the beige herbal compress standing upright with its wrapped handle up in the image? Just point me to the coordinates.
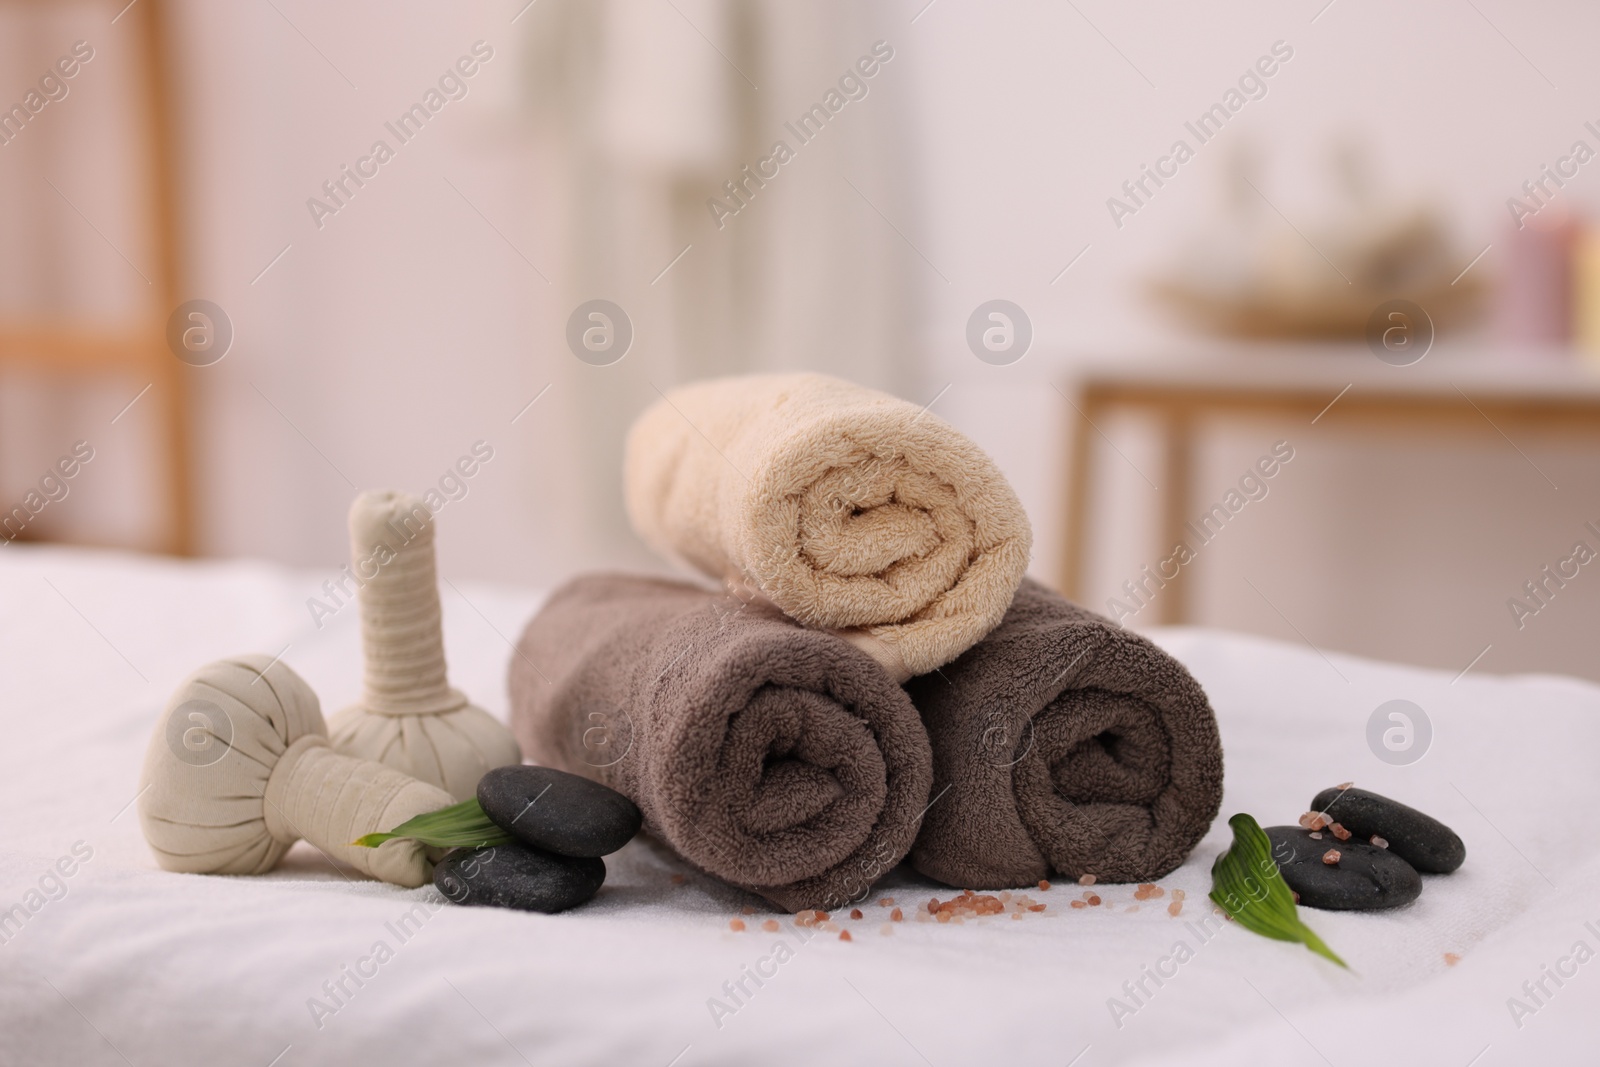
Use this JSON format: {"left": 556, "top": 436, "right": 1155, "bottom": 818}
{"left": 330, "top": 491, "right": 522, "bottom": 800}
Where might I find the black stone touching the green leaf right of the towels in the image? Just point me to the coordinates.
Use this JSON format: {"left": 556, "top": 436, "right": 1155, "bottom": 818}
{"left": 1266, "top": 825, "right": 1422, "bottom": 912}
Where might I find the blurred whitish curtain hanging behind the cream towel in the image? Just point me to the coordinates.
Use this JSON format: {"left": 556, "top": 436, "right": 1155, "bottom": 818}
{"left": 523, "top": 0, "right": 918, "bottom": 563}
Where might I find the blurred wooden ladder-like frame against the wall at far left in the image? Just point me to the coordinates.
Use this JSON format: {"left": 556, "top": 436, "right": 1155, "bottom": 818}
{"left": 0, "top": 0, "right": 195, "bottom": 555}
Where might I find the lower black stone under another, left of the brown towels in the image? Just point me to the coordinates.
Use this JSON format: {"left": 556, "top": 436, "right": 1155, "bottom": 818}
{"left": 434, "top": 845, "right": 605, "bottom": 913}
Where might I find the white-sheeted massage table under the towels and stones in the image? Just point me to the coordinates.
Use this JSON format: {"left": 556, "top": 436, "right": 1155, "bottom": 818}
{"left": 0, "top": 544, "right": 1600, "bottom": 1067}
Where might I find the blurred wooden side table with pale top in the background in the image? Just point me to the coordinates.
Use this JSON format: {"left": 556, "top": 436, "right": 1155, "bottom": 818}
{"left": 1061, "top": 346, "right": 1600, "bottom": 624}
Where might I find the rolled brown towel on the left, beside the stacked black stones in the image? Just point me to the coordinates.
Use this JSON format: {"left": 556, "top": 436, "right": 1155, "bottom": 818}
{"left": 510, "top": 576, "right": 933, "bottom": 910}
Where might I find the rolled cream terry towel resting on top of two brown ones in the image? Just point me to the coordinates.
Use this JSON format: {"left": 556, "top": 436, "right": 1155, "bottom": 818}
{"left": 624, "top": 374, "right": 1032, "bottom": 681}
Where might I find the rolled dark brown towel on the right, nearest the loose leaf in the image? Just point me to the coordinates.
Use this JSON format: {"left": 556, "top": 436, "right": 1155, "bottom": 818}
{"left": 907, "top": 579, "right": 1222, "bottom": 889}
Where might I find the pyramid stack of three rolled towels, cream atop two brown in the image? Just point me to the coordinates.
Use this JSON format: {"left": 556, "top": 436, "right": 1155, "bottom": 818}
{"left": 510, "top": 374, "right": 1222, "bottom": 910}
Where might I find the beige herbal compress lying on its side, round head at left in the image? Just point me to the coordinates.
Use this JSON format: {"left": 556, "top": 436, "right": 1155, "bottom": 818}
{"left": 139, "top": 656, "right": 453, "bottom": 886}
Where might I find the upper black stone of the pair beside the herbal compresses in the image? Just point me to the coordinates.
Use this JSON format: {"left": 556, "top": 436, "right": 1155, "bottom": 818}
{"left": 478, "top": 766, "right": 645, "bottom": 856}
